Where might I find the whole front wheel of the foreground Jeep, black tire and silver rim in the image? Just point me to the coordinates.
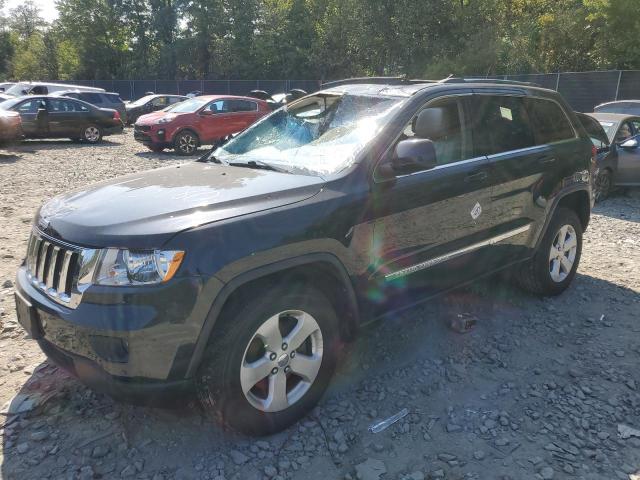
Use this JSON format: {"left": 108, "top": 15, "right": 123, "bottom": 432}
{"left": 196, "top": 285, "right": 340, "bottom": 435}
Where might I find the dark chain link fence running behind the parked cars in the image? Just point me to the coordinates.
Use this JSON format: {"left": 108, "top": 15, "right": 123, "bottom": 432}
{"left": 58, "top": 70, "right": 640, "bottom": 112}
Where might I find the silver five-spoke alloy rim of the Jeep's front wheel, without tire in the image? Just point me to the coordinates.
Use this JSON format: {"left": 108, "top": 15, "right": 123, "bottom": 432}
{"left": 240, "top": 310, "right": 324, "bottom": 412}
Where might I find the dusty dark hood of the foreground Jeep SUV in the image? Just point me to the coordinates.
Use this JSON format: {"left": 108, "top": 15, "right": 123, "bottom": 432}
{"left": 36, "top": 162, "right": 324, "bottom": 248}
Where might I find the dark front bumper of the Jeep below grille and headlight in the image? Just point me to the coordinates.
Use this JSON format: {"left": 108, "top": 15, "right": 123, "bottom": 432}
{"left": 16, "top": 267, "right": 204, "bottom": 397}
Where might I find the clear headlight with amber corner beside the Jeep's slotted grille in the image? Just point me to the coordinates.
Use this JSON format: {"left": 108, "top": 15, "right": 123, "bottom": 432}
{"left": 94, "top": 248, "right": 184, "bottom": 285}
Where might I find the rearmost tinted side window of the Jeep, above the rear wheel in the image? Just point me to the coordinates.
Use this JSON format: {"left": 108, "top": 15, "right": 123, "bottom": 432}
{"left": 524, "top": 98, "right": 576, "bottom": 145}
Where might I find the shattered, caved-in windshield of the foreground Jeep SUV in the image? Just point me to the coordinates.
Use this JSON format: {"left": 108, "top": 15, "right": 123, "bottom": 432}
{"left": 213, "top": 95, "right": 400, "bottom": 175}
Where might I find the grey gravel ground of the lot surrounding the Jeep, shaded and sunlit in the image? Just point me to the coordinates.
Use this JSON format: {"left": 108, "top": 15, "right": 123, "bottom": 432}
{"left": 0, "top": 132, "right": 640, "bottom": 480}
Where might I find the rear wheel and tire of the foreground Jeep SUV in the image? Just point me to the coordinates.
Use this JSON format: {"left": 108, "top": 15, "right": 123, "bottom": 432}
{"left": 516, "top": 207, "right": 582, "bottom": 296}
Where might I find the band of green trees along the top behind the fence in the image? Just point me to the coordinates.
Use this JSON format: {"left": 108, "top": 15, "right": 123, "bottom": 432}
{"left": 0, "top": 0, "right": 640, "bottom": 80}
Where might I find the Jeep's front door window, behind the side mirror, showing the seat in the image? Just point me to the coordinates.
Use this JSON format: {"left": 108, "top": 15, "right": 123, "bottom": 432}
{"left": 402, "top": 98, "right": 471, "bottom": 165}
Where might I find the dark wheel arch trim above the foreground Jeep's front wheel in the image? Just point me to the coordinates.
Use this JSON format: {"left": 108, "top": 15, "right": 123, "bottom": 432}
{"left": 186, "top": 253, "right": 360, "bottom": 377}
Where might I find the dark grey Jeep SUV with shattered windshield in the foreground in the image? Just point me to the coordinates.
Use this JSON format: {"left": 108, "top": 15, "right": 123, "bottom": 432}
{"left": 16, "top": 80, "right": 593, "bottom": 434}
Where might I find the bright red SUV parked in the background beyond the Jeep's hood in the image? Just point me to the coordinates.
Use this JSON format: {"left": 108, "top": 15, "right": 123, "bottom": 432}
{"left": 134, "top": 95, "right": 271, "bottom": 155}
